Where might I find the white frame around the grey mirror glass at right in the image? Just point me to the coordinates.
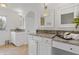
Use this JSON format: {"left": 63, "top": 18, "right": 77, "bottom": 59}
{"left": 55, "top": 6, "right": 77, "bottom": 27}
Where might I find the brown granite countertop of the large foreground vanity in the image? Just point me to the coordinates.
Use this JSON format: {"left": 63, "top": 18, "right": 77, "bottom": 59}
{"left": 30, "top": 34, "right": 79, "bottom": 46}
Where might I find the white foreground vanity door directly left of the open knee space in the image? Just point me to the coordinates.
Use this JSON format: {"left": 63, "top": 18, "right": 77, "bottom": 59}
{"left": 38, "top": 38, "right": 52, "bottom": 55}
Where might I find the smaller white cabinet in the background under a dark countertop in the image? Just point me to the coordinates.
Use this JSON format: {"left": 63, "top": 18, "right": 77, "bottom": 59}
{"left": 11, "top": 32, "right": 27, "bottom": 46}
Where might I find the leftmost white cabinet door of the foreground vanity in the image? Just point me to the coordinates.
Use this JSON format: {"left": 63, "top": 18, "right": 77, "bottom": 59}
{"left": 28, "top": 38, "right": 37, "bottom": 55}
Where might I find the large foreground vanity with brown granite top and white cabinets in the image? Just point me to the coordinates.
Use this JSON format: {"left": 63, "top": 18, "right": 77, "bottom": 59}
{"left": 28, "top": 31, "right": 79, "bottom": 55}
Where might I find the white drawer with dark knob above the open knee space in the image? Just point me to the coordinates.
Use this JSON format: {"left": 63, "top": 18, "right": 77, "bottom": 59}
{"left": 53, "top": 41, "right": 79, "bottom": 54}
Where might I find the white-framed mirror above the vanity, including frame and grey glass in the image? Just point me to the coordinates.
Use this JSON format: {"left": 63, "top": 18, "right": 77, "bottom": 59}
{"left": 56, "top": 6, "right": 76, "bottom": 27}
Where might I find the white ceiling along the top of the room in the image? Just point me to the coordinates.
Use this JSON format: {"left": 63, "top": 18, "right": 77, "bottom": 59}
{"left": 0, "top": 3, "right": 76, "bottom": 13}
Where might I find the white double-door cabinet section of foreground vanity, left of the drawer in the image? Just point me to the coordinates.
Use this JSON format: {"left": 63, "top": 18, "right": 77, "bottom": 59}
{"left": 28, "top": 35, "right": 52, "bottom": 55}
